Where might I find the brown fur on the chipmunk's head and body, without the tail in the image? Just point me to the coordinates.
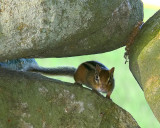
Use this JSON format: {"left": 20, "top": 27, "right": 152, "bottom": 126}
{"left": 74, "top": 62, "right": 114, "bottom": 99}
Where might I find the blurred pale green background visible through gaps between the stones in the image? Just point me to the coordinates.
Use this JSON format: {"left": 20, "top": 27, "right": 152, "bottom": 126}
{"left": 36, "top": 2, "right": 160, "bottom": 128}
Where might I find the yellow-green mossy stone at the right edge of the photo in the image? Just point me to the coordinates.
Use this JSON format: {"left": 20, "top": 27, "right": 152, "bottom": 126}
{"left": 129, "top": 10, "right": 160, "bottom": 121}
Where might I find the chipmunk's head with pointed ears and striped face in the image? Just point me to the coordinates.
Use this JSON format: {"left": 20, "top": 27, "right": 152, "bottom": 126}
{"left": 95, "top": 65, "right": 114, "bottom": 92}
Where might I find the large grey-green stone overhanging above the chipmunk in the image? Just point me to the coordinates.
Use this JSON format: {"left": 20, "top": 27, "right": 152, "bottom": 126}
{"left": 0, "top": 0, "right": 143, "bottom": 61}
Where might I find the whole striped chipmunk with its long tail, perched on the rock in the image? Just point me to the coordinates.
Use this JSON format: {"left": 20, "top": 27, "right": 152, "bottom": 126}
{"left": 29, "top": 61, "right": 114, "bottom": 99}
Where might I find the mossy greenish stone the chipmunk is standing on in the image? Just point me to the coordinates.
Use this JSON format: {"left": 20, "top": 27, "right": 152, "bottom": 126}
{"left": 0, "top": 68, "right": 139, "bottom": 128}
